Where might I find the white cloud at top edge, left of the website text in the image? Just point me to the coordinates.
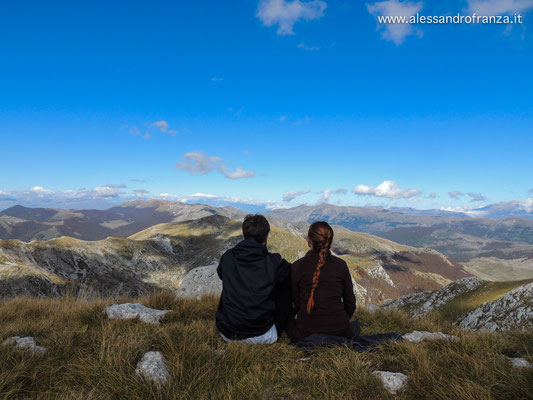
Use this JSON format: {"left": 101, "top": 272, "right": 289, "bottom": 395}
{"left": 257, "top": 0, "right": 327, "bottom": 35}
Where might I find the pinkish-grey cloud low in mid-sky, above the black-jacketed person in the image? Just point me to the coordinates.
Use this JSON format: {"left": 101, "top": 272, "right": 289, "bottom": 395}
{"left": 174, "top": 151, "right": 255, "bottom": 179}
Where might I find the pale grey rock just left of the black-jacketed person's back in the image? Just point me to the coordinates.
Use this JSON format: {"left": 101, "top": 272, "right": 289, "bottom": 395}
{"left": 176, "top": 264, "right": 222, "bottom": 299}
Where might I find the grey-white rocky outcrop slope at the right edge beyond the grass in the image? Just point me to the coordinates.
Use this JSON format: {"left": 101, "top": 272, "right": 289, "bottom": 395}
{"left": 457, "top": 283, "right": 533, "bottom": 331}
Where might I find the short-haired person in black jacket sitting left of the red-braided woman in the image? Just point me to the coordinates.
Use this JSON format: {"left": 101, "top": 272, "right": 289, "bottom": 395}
{"left": 216, "top": 215, "right": 292, "bottom": 344}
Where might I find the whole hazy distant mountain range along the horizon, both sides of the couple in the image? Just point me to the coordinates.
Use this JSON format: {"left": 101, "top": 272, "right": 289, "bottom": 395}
{"left": 0, "top": 200, "right": 533, "bottom": 280}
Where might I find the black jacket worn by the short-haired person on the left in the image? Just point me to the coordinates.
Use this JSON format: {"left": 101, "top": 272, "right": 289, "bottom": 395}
{"left": 216, "top": 238, "right": 291, "bottom": 340}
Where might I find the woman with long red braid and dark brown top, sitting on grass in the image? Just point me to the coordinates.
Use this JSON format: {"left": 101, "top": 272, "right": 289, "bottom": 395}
{"left": 288, "top": 221, "right": 359, "bottom": 342}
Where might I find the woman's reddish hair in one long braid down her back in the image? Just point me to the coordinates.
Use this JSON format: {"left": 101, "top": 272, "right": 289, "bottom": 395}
{"left": 307, "top": 221, "right": 333, "bottom": 314}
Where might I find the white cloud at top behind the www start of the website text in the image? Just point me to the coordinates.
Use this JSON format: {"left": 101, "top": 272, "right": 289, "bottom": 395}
{"left": 366, "top": 0, "right": 424, "bottom": 46}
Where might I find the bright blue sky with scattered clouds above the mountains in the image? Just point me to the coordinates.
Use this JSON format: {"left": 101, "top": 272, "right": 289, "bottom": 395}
{"left": 0, "top": 0, "right": 533, "bottom": 209}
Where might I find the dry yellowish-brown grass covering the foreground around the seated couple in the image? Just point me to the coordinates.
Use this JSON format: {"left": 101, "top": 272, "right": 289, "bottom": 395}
{"left": 0, "top": 293, "right": 533, "bottom": 400}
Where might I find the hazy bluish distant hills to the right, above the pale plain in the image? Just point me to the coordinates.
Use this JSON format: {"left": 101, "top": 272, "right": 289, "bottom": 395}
{"left": 268, "top": 204, "right": 533, "bottom": 260}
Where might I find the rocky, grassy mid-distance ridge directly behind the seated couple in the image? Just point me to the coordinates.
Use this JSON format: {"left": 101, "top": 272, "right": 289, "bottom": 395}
{"left": 0, "top": 215, "right": 471, "bottom": 304}
